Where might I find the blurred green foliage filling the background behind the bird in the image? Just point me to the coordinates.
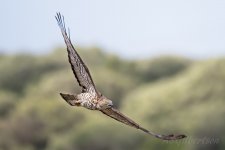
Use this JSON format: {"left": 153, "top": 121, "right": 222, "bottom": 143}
{"left": 0, "top": 47, "right": 225, "bottom": 150}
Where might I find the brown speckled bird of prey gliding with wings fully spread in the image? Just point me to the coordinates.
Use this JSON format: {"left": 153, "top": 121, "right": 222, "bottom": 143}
{"left": 55, "top": 13, "right": 186, "bottom": 140}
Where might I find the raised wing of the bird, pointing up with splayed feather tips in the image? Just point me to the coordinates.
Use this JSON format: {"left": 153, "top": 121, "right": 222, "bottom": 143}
{"left": 55, "top": 13, "right": 97, "bottom": 94}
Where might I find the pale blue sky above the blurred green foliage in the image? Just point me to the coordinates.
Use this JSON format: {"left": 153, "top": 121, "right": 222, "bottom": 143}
{"left": 0, "top": 0, "right": 225, "bottom": 58}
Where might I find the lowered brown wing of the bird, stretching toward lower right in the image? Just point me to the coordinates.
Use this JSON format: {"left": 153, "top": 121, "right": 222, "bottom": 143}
{"left": 101, "top": 108, "right": 186, "bottom": 140}
